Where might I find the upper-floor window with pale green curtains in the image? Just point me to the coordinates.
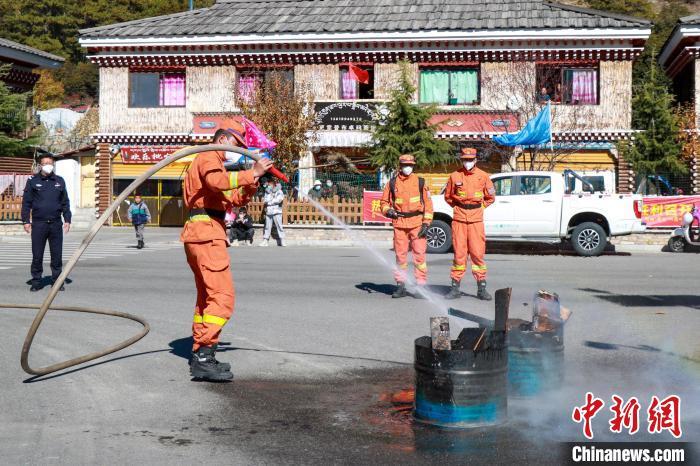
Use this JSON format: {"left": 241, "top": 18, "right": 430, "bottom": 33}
{"left": 419, "top": 68, "right": 479, "bottom": 105}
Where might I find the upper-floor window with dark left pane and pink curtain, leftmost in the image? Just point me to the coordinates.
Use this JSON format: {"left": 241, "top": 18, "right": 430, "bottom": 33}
{"left": 129, "top": 72, "right": 185, "bottom": 107}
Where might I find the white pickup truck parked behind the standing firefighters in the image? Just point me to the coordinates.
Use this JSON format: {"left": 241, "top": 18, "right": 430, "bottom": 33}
{"left": 428, "top": 170, "right": 645, "bottom": 256}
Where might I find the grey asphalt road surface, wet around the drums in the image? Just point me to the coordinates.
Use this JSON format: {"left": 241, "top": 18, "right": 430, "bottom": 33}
{"left": 0, "top": 230, "right": 700, "bottom": 464}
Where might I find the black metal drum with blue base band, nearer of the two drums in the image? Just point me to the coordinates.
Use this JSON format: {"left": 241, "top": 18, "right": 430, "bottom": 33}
{"left": 414, "top": 329, "right": 508, "bottom": 428}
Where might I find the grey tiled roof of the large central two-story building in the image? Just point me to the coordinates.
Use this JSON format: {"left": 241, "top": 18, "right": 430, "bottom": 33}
{"left": 80, "top": 0, "right": 650, "bottom": 39}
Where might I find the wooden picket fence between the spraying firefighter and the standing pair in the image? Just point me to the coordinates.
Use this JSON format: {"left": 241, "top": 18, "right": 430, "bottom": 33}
{"left": 247, "top": 196, "right": 362, "bottom": 225}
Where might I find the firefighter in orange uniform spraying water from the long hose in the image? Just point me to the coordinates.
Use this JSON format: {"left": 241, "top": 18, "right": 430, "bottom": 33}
{"left": 180, "top": 122, "right": 272, "bottom": 380}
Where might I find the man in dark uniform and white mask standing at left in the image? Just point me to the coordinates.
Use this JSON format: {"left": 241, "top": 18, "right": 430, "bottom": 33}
{"left": 22, "top": 155, "right": 71, "bottom": 291}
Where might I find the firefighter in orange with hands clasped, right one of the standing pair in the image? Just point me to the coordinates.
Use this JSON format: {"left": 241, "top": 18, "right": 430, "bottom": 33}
{"left": 445, "top": 147, "right": 496, "bottom": 301}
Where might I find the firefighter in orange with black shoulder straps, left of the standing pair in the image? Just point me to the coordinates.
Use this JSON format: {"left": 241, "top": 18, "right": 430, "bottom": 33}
{"left": 381, "top": 154, "right": 433, "bottom": 298}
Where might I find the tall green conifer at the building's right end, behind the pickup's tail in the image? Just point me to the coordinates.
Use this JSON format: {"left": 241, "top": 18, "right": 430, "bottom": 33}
{"left": 621, "top": 53, "right": 688, "bottom": 174}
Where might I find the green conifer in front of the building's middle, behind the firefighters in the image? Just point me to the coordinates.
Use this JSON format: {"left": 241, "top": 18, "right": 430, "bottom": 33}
{"left": 369, "top": 62, "right": 454, "bottom": 169}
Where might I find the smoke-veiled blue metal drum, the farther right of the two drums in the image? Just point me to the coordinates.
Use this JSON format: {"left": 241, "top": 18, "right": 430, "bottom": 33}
{"left": 508, "top": 329, "right": 564, "bottom": 397}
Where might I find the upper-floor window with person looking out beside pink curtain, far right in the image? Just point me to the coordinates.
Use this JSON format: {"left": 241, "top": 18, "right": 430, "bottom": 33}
{"left": 537, "top": 65, "right": 599, "bottom": 105}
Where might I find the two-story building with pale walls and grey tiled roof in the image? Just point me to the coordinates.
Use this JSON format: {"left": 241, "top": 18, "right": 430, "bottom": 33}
{"left": 80, "top": 0, "right": 650, "bottom": 223}
